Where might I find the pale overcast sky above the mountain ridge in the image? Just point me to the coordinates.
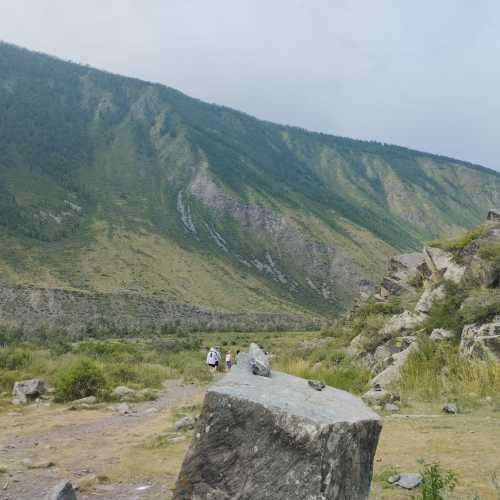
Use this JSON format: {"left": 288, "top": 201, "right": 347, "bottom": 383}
{"left": 0, "top": 0, "right": 500, "bottom": 170}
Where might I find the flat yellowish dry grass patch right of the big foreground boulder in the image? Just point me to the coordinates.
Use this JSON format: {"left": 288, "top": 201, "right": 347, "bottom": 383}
{"left": 371, "top": 407, "right": 500, "bottom": 500}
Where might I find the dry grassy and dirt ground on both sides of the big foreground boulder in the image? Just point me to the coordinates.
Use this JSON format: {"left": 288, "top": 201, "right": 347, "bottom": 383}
{"left": 0, "top": 380, "right": 500, "bottom": 500}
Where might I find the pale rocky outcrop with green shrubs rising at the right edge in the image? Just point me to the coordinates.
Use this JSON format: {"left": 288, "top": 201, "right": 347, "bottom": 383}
{"left": 349, "top": 216, "right": 500, "bottom": 394}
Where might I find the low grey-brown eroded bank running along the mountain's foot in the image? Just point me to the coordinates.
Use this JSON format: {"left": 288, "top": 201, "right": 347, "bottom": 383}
{"left": 0, "top": 282, "right": 320, "bottom": 336}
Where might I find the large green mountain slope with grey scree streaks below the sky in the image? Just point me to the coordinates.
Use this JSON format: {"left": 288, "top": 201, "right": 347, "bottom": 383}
{"left": 0, "top": 44, "right": 500, "bottom": 314}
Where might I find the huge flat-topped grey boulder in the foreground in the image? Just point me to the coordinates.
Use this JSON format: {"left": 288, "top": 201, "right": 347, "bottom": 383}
{"left": 174, "top": 348, "right": 381, "bottom": 500}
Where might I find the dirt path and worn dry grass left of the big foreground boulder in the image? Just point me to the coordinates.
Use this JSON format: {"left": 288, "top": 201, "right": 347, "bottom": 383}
{"left": 0, "top": 380, "right": 203, "bottom": 500}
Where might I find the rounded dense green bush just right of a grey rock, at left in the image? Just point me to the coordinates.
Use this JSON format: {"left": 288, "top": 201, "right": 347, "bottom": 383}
{"left": 55, "top": 358, "right": 106, "bottom": 402}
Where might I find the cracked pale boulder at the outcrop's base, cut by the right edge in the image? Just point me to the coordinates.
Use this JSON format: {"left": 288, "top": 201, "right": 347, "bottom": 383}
{"left": 460, "top": 322, "right": 500, "bottom": 361}
